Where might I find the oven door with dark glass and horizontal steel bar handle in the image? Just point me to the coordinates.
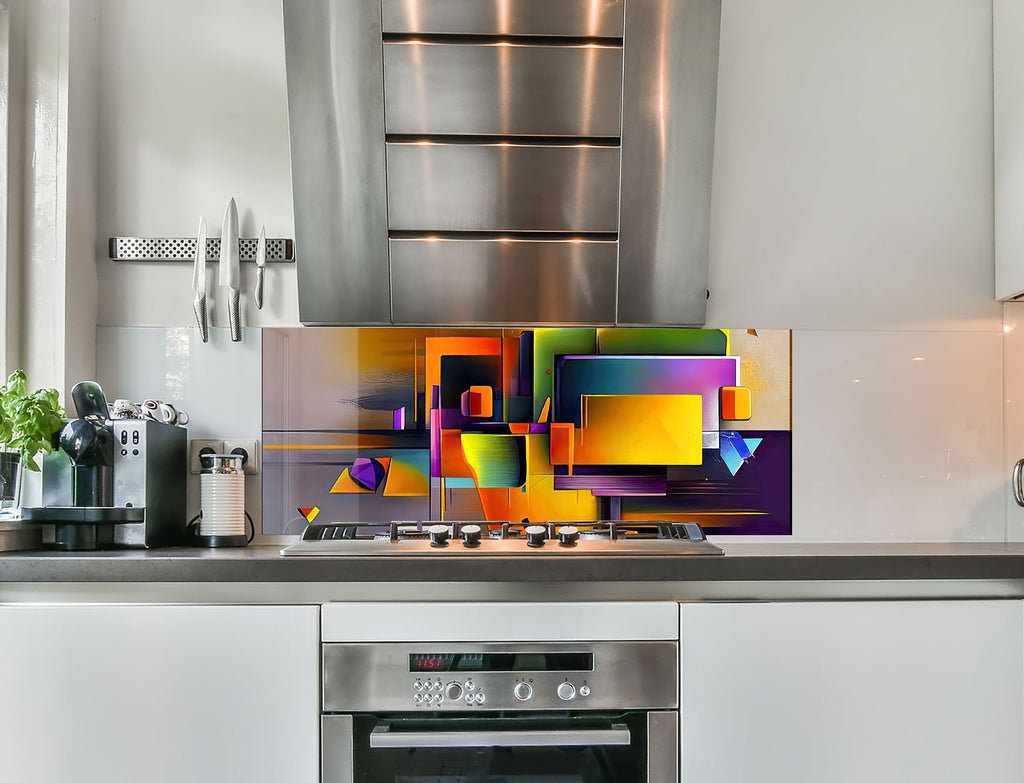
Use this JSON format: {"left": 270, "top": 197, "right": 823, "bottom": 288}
{"left": 321, "top": 711, "right": 679, "bottom": 783}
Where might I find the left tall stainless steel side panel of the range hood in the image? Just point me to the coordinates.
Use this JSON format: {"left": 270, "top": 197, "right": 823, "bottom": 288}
{"left": 284, "top": 0, "right": 391, "bottom": 324}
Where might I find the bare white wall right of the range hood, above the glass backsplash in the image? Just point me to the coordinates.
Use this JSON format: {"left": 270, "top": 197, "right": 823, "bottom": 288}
{"left": 708, "top": 0, "right": 995, "bottom": 332}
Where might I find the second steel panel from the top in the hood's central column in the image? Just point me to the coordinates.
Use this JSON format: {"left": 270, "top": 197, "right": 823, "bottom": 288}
{"left": 384, "top": 41, "right": 623, "bottom": 139}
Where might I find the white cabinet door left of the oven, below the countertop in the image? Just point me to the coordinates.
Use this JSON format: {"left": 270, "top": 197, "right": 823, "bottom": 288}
{"left": 0, "top": 606, "right": 319, "bottom": 783}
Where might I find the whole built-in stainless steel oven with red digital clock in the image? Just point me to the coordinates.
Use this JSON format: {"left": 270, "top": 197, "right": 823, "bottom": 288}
{"left": 322, "top": 641, "right": 679, "bottom": 783}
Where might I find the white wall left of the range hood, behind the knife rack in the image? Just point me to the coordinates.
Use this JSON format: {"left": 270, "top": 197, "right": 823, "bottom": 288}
{"left": 98, "top": 0, "right": 298, "bottom": 327}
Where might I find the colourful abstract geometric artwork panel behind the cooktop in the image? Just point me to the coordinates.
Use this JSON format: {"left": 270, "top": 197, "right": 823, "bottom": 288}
{"left": 263, "top": 329, "right": 792, "bottom": 535}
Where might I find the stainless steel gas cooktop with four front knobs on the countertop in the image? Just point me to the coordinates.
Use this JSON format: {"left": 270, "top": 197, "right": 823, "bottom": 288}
{"left": 281, "top": 521, "right": 723, "bottom": 557}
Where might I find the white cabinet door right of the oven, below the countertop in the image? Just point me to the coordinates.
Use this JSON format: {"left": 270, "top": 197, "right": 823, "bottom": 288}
{"left": 680, "top": 601, "right": 1024, "bottom": 783}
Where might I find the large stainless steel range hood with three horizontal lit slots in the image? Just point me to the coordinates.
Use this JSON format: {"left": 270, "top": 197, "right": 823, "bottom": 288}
{"left": 284, "top": 0, "right": 721, "bottom": 325}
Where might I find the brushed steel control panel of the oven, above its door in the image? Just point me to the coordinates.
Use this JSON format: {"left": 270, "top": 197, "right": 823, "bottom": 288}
{"left": 322, "top": 638, "right": 678, "bottom": 713}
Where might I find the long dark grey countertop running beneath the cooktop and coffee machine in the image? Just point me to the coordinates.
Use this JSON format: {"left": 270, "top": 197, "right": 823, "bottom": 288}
{"left": 0, "top": 542, "right": 1024, "bottom": 583}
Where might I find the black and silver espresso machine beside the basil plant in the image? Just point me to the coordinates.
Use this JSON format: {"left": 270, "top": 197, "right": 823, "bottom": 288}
{"left": 22, "top": 381, "right": 188, "bottom": 550}
